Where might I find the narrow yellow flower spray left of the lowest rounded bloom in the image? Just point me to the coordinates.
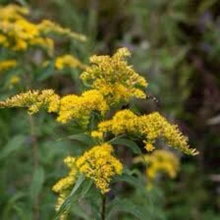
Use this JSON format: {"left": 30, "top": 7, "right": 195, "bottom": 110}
{"left": 52, "top": 157, "right": 78, "bottom": 220}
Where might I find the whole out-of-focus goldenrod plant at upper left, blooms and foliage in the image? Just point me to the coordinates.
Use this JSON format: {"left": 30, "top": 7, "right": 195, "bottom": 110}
{"left": 0, "top": 4, "right": 86, "bottom": 92}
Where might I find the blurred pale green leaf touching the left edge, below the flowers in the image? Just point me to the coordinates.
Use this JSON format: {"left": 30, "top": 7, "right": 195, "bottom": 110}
{"left": 0, "top": 135, "right": 25, "bottom": 160}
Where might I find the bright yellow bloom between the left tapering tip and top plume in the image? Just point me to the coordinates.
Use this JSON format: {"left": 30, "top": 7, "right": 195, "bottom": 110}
{"left": 57, "top": 90, "right": 108, "bottom": 123}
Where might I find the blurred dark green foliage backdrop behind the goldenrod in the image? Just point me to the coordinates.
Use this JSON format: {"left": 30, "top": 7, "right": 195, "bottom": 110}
{"left": 0, "top": 0, "right": 220, "bottom": 220}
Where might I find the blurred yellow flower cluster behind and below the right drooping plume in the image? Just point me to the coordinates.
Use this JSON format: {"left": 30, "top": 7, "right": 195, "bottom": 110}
{"left": 134, "top": 150, "right": 180, "bottom": 187}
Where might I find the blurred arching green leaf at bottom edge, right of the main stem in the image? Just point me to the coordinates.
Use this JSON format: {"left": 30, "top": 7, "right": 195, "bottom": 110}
{"left": 106, "top": 199, "right": 150, "bottom": 220}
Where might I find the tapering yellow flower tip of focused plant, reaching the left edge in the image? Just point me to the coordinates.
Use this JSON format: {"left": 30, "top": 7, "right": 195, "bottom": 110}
{"left": 0, "top": 89, "right": 59, "bottom": 114}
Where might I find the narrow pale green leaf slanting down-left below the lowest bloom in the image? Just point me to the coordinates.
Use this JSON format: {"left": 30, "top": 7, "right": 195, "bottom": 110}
{"left": 54, "top": 175, "right": 85, "bottom": 220}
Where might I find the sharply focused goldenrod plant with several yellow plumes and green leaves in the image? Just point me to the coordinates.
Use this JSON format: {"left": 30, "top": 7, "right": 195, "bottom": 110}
{"left": 0, "top": 47, "right": 198, "bottom": 220}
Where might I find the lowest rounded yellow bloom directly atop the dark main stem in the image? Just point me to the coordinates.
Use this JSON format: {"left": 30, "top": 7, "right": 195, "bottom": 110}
{"left": 76, "top": 143, "right": 123, "bottom": 194}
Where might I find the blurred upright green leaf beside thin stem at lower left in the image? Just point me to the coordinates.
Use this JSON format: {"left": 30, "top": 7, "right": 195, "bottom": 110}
{"left": 30, "top": 167, "right": 45, "bottom": 200}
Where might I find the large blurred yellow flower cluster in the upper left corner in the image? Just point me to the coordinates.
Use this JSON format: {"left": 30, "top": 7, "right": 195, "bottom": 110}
{"left": 0, "top": 5, "right": 85, "bottom": 54}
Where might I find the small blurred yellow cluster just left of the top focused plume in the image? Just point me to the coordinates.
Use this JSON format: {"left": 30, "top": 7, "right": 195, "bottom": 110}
{"left": 55, "top": 54, "right": 85, "bottom": 70}
